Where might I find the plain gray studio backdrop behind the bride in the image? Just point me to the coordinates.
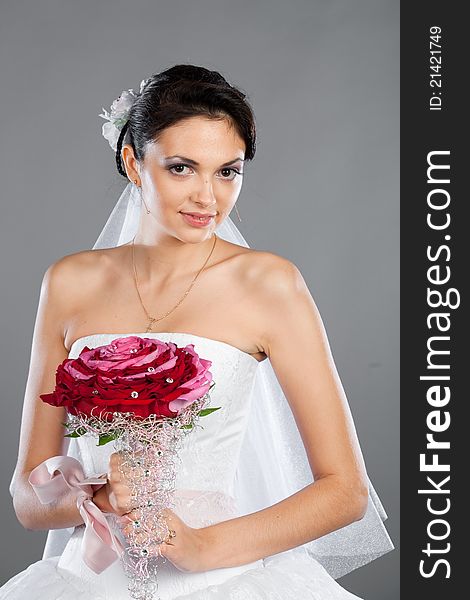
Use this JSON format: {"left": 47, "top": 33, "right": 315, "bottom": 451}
{"left": 0, "top": 0, "right": 399, "bottom": 600}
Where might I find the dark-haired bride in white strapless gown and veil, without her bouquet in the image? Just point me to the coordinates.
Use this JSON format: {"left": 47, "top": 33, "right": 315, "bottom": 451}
{"left": 0, "top": 65, "right": 393, "bottom": 600}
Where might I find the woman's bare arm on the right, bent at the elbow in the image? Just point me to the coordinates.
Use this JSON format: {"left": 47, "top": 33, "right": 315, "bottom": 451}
{"left": 201, "top": 255, "right": 368, "bottom": 569}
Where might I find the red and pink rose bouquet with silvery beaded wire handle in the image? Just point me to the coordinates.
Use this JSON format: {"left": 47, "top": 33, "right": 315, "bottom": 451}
{"left": 31, "top": 336, "right": 220, "bottom": 599}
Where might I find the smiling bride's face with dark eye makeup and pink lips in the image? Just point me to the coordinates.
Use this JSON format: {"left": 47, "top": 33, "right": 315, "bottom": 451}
{"left": 122, "top": 117, "right": 245, "bottom": 241}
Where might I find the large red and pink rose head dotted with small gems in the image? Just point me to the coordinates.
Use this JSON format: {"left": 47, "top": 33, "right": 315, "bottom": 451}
{"left": 40, "top": 335, "right": 212, "bottom": 418}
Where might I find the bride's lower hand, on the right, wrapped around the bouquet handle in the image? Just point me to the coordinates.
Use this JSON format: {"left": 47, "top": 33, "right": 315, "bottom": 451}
{"left": 119, "top": 508, "right": 207, "bottom": 573}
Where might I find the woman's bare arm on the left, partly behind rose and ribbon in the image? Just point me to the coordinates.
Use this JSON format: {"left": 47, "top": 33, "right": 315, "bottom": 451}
{"left": 10, "top": 257, "right": 90, "bottom": 529}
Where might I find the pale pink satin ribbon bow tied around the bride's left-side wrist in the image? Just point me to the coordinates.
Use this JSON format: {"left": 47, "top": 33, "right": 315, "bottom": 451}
{"left": 28, "top": 456, "right": 124, "bottom": 573}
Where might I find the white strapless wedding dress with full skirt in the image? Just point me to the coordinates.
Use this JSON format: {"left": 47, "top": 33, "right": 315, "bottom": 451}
{"left": 0, "top": 332, "right": 366, "bottom": 600}
